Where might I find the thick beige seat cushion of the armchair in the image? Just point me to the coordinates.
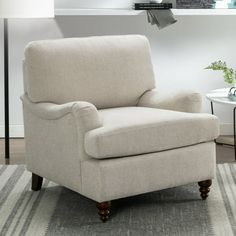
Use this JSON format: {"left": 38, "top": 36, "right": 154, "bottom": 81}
{"left": 85, "top": 107, "right": 219, "bottom": 159}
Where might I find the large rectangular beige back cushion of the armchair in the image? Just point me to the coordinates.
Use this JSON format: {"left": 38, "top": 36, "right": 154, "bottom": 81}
{"left": 24, "top": 35, "right": 155, "bottom": 108}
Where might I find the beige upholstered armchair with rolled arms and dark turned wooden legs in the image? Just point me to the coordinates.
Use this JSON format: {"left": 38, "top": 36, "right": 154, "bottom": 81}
{"left": 22, "top": 35, "right": 219, "bottom": 222}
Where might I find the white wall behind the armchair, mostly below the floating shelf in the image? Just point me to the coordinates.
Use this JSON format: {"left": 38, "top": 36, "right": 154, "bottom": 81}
{"left": 0, "top": 4, "right": 236, "bottom": 136}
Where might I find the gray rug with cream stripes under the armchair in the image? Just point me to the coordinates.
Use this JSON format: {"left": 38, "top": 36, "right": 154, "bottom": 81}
{"left": 0, "top": 164, "right": 236, "bottom": 236}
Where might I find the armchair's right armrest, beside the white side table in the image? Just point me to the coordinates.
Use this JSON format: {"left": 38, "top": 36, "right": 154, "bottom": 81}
{"left": 138, "top": 90, "right": 202, "bottom": 113}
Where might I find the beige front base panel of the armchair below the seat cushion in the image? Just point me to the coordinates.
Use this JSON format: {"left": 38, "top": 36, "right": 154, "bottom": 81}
{"left": 81, "top": 142, "right": 216, "bottom": 202}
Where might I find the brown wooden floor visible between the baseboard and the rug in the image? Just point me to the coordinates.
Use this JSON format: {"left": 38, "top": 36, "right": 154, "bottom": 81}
{"left": 0, "top": 139, "right": 235, "bottom": 165}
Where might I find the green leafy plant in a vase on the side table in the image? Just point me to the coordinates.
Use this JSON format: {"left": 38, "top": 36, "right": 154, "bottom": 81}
{"left": 205, "top": 61, "right": 236, "bottom": 101}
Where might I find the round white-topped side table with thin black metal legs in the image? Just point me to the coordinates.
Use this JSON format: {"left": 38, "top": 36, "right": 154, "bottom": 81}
{"left": 206, "top": 88, "right": 236, "bottom": 160}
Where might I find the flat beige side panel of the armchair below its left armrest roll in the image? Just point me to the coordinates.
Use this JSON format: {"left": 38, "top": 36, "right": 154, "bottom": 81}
{"left": 23, "top": 102, "right": 83, "bottom": 191}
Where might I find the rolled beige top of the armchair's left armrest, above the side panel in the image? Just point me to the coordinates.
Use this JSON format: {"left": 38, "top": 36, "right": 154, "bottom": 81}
{"left": 21, "top": 95, "right": 102, "bottom": 130}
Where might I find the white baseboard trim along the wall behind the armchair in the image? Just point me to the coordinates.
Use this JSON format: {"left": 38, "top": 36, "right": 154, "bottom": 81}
{"left": 0, "top": 123, "right": 233, "bottom": 138}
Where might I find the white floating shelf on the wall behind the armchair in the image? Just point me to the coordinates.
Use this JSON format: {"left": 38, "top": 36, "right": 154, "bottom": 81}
{"left": 55, "top": 9, "right": 236, "bottom": 16}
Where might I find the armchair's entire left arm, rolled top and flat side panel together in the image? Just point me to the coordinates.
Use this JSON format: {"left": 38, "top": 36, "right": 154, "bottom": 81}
{"left": 21, "top": 95, "right": 102, "bottom": 194}
